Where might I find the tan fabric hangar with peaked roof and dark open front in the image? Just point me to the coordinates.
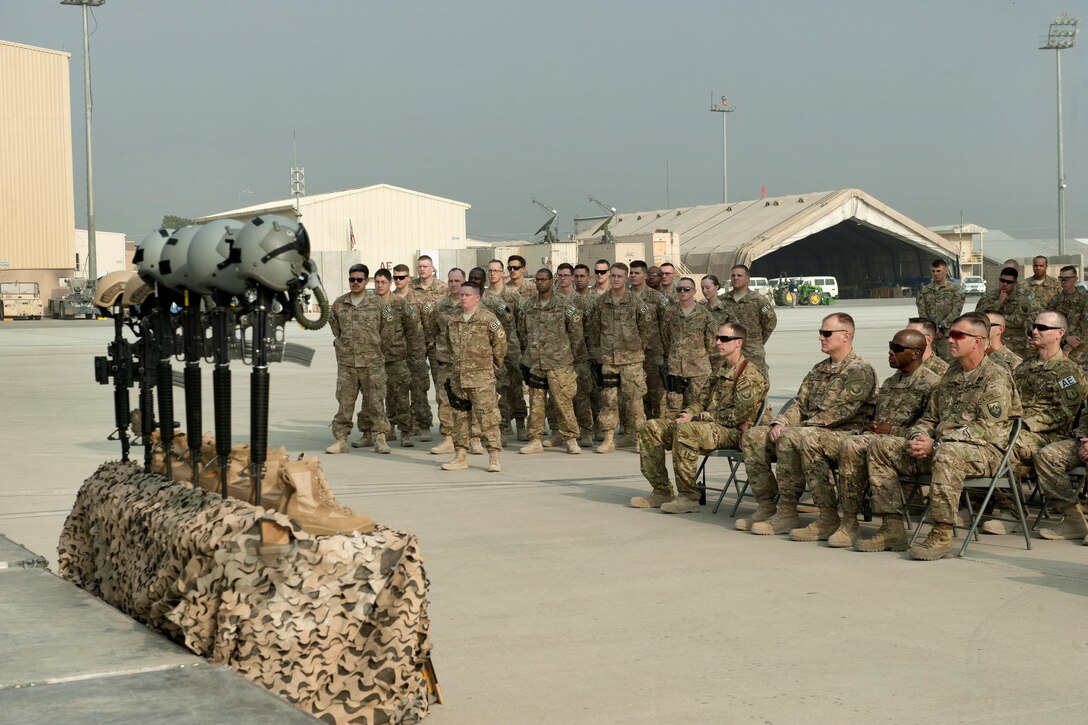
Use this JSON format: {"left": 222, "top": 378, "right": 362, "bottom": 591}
{"left": 580, "top": 188, "right": 970, "bottom": 297}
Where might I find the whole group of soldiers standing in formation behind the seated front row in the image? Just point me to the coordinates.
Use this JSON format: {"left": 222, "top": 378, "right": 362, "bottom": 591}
{"left": 326, "top": 255, "right": 777, "bottom": 470}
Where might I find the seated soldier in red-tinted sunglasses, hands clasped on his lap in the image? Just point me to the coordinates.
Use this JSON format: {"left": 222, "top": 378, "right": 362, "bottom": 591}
{"left": 854, "top": 312, "right": 1021, "bottom": 561}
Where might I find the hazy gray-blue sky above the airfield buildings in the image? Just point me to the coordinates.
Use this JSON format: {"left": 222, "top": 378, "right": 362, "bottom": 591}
{"left": 0, "top": 0, "right": 1088, "bottom": 239}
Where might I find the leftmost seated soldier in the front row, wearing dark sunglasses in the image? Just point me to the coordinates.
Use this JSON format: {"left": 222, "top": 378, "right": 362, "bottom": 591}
{"left": 631, "top": 322, "right": 768, "bottom": 514}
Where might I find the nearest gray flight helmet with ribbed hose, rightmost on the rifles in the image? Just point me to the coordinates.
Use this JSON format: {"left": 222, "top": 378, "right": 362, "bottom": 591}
{"left": 237, "top": 214, "right": 310, "bottom": 292}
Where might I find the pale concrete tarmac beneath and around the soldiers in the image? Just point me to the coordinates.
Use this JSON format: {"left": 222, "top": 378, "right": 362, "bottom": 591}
{"left": 0, "top": 299, "right": 1088, "bottom": 725}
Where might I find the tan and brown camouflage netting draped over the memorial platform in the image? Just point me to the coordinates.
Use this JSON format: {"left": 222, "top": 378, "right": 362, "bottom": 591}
{"left": 59, "top": 463, "right": 431, "bottom": 724}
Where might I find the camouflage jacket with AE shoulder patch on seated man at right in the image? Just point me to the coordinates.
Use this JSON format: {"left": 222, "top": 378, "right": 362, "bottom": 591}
{"left": 1013, "top": 352, "right": 1088, "bottom": 465}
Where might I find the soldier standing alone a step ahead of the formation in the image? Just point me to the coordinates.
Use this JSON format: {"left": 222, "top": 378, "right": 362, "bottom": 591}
{"left": 442, "top": 282, "right": 507, "bottom": 474}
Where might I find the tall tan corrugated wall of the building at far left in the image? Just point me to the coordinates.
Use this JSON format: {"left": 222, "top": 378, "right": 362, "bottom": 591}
{"left": 0, "top": 40, "right": 75, "bottom": 270}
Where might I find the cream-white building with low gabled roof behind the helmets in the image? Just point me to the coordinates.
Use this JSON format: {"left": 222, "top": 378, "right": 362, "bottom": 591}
{"left": 197, "top": 184, "right": 471, "bottom": 299}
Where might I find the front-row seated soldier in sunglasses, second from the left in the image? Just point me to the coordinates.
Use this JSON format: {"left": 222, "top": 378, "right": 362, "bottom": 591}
{"left": 735, "top": 312, "right": 877, "bottom": 534}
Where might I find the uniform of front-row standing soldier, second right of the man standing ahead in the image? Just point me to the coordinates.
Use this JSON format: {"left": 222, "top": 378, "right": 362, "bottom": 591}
{"left": 586, "top": 291, "right": 656, "bottom": 432}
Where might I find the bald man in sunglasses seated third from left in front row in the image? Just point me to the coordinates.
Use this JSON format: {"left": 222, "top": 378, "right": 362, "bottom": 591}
{"left": 790, "top": 330, "right": 943, "bottom": 549}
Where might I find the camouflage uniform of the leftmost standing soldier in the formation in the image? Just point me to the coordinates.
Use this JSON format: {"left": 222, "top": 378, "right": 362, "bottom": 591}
{"left": 329, "top": 293, "right": 390, "bottom": 440}
